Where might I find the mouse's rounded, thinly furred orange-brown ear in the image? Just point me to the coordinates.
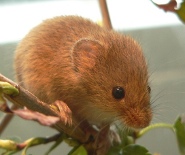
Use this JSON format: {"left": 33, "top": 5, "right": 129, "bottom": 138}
{"left": 72, "top": 39, "right": 103, "bottom": 72}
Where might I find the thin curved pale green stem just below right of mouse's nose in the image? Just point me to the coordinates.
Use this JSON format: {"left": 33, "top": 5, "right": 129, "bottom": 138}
{"left": 136, "top": 123, "right": 174, "bottom": 138}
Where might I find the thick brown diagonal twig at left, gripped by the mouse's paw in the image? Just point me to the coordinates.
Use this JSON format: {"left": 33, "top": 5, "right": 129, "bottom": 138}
{"left": 0, "top": 74, "right": 87, "bottom": 143}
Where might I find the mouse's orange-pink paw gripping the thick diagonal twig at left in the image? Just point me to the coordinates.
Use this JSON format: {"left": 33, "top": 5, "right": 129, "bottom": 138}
{"left": 50, "top": 100, "right": 72, "bottom": 125}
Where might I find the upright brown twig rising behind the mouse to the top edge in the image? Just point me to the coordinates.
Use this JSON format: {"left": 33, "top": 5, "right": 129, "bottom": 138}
{"left": 99, "top": 0, "right": 112, "bottom": 29}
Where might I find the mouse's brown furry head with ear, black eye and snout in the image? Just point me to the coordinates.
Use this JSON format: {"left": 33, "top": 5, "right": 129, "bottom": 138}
{"left": 72, "top": 35, "right": 152, "bottom": 129}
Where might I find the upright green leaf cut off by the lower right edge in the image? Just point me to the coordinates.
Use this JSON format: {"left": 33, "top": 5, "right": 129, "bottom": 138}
{"left": 174, "top": 117, "right": 185, "bottom": 155}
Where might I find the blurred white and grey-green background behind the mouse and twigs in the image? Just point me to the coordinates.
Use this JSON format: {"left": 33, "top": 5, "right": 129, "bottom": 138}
{"left": 0, "top": 0, "right": 185, "bottom": 155}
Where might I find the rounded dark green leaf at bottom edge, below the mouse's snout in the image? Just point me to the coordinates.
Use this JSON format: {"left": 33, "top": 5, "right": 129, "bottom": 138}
{"left": 123, "top": 144, "right": 151, "bottom": 155}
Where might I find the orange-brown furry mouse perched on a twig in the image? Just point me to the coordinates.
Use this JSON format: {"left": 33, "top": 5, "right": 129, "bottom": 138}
{"left": 14, "top": 15, "right": 152, "bottom": 129}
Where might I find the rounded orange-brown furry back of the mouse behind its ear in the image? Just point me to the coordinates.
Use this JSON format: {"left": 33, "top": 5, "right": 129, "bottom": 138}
{"left": 14, "top": 16, "right": 100, "bottom": 102}
